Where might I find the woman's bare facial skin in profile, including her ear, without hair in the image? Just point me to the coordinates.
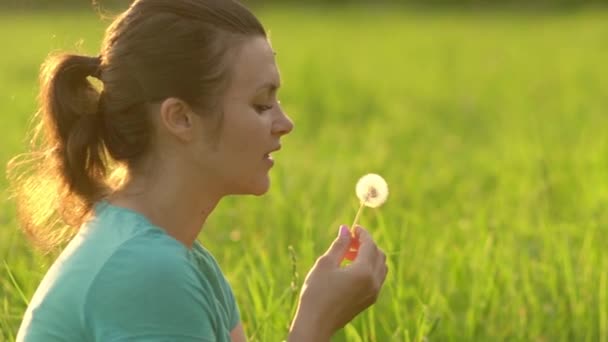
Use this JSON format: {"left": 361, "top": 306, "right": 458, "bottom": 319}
{"left": 162, "top": 37, "right": 293, "bottom": 196}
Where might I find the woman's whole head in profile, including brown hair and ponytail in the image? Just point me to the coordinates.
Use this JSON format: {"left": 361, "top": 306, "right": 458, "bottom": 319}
{"left": 9, "top": 0, "right": 292, "bottom": 251}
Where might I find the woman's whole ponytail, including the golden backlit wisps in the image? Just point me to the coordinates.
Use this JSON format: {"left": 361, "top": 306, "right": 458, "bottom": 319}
{"left": 7, "top": 54, "right": 108, "bottom": 249}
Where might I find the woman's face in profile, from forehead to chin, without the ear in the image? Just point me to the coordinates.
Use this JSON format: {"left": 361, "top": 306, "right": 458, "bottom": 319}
{"left": 191, "top": 37, "right": 293, "bottom": 195}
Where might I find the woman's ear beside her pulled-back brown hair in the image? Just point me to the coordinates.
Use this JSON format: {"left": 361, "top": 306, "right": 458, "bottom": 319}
{"left": 160, "top": 97, "right": 196, "bottom": 142}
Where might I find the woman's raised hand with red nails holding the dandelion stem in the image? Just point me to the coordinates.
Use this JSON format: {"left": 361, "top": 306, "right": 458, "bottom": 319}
{"left": 289, "top": 226, "right": 388, "bottom": 342}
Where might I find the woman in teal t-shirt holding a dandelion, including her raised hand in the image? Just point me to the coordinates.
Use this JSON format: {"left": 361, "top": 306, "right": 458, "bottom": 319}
{"left": 13, "top": 0, "right": 387, "bottom": 342}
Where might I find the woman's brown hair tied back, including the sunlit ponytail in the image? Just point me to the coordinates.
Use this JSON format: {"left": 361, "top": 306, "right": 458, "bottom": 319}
{"left": 7, "top": 0, "right": 266, "bottom": 250}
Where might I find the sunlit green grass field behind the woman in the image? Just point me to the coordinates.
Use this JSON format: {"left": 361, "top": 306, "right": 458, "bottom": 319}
{"left": 0, "top": 6, "right": 608, "bottom": 342}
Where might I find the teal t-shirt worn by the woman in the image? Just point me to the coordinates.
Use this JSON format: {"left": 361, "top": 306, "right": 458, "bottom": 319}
{"left": 17, "top": 201, "right": 239, "bottom": 342}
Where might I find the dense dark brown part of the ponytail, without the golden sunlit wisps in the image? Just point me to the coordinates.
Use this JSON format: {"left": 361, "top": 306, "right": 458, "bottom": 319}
{"left": 40, "top": 55, "right": 106, "bottom": 203}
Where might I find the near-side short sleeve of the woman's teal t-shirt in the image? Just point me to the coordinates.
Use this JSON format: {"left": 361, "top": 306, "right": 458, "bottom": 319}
{"left": 83, "top": 238, "right": 216, "bottom": 342}
